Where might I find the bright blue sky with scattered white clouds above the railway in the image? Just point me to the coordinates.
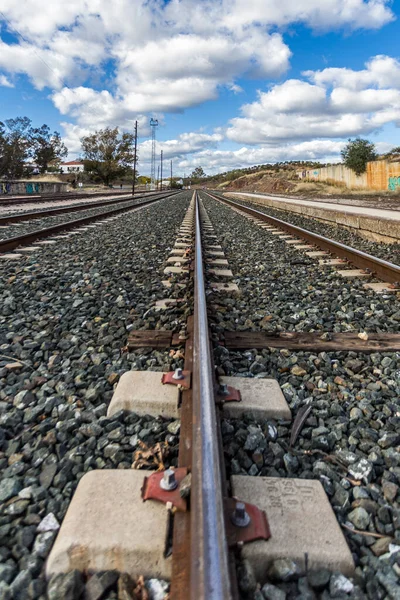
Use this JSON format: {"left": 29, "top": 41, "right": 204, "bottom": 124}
{"left": 0, "top": 0, "right": 400, "bottom": 175}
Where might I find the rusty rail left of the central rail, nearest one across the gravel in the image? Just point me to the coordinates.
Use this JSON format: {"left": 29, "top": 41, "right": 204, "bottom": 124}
{"left": 0, "top": 192, "right": 177, "bottom": 253}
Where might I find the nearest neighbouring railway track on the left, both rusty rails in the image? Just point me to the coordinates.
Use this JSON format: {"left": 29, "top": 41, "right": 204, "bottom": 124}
{"left": 0, "top": 192, "right": 178, "bottom": 253}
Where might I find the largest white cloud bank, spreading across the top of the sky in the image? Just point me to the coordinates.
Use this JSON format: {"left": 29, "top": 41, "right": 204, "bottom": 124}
{"left": 0, "top": 0, "right": 393, "bottom": 114}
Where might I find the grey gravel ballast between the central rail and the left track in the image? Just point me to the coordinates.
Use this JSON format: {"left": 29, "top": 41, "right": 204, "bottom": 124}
{"left": 0, "top": 193, "right": 191, "bottom": 600}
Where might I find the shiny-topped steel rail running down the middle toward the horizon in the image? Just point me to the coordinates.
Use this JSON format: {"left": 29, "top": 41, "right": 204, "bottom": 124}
{"left": 190, "top": 192, "right": 232, "bottom": 600}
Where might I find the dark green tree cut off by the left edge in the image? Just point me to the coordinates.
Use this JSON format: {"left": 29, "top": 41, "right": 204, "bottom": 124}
{"left": 0, "top": 117, "right": 32, "bottom": 180}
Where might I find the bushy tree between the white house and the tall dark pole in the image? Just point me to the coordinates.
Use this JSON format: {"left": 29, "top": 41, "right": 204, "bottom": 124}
{"left": 81, "top": 127, "right": 134, "bottom": 185}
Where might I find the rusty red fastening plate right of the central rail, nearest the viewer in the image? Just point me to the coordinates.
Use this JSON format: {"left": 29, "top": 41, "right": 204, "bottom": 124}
{"left": 224, "top": 498, "right": 271, "bottom": 548}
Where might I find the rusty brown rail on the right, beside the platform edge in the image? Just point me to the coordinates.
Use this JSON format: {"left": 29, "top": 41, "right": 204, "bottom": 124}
{"left": 205, "top": 192, "right": 400, "bottom": 283}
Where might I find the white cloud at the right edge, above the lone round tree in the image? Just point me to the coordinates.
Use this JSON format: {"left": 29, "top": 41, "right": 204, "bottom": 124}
{"left": 227, "top": 56, "right": 400, "bottom": 144}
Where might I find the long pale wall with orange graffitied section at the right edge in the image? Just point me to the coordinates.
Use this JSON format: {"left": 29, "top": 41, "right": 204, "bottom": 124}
{"left": 298, "top": 160, "right": 400, "bottom": 191}
